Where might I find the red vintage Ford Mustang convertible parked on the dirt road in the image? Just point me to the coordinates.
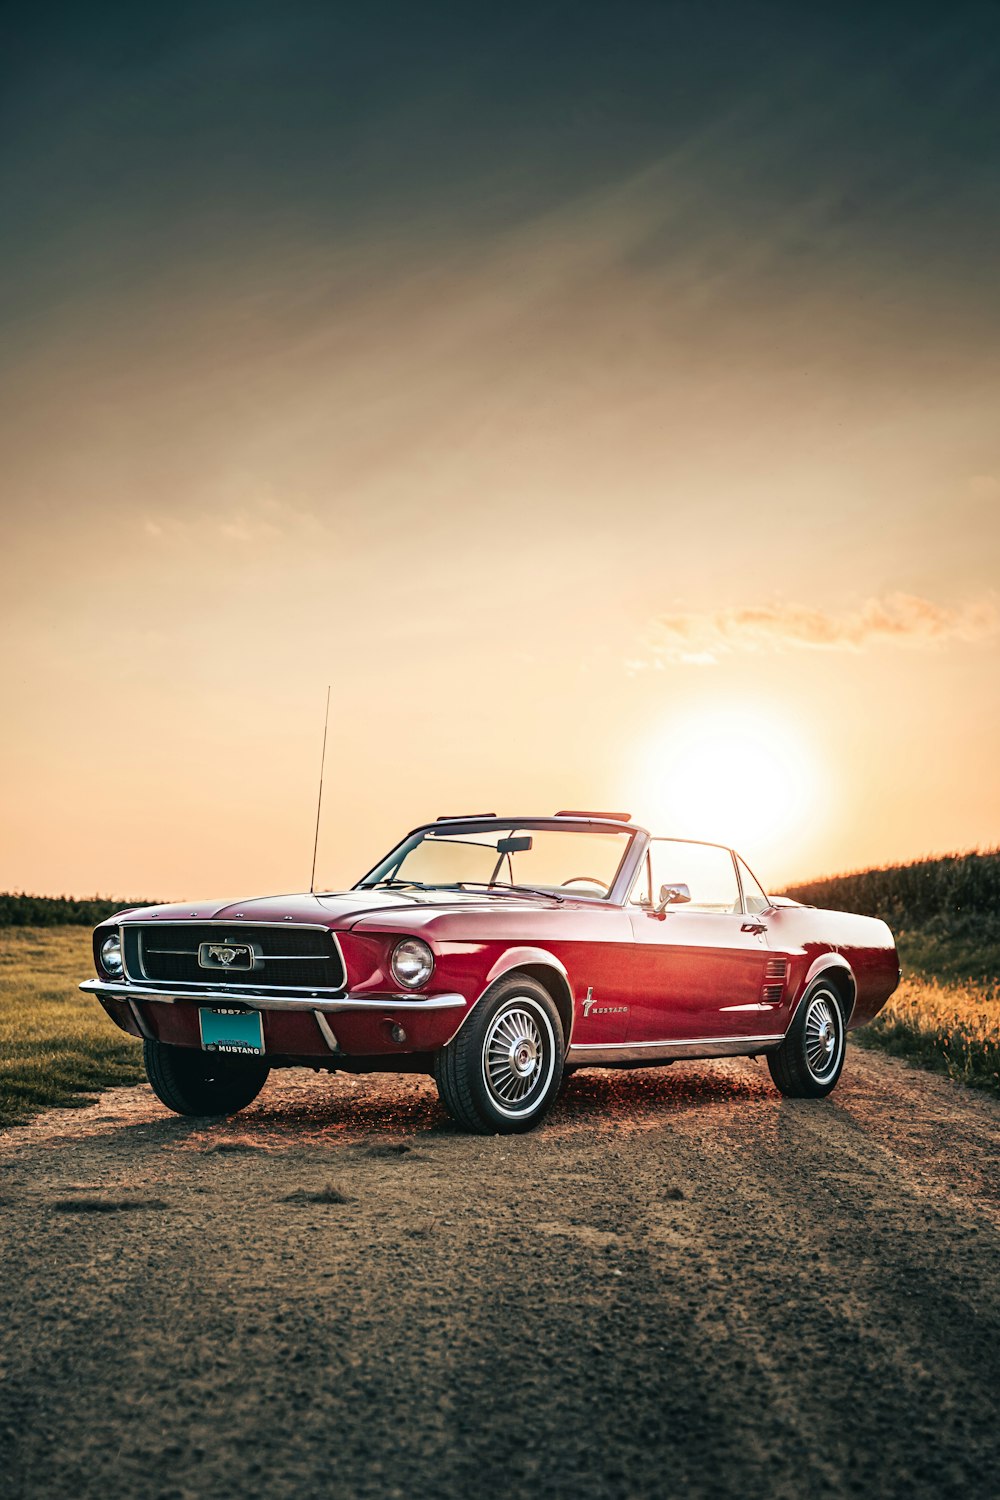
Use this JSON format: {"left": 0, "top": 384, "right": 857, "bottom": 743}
{"left": 81, "top": 812, "right": 900, "bottom": 1134}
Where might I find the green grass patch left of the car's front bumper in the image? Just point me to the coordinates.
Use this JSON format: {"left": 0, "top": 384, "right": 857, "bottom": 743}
{"left": 0, "top": 927, "right": 145, "bottom": 1125}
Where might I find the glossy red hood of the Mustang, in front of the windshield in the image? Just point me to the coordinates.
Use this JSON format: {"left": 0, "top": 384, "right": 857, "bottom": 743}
{"left": 111, "top": 891, "right": 566, "bottom": 929}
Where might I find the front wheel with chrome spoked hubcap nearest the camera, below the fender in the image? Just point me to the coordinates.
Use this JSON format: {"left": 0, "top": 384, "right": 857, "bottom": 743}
{"left": 433, "top": 974, "right": 565, "bottom": 1136}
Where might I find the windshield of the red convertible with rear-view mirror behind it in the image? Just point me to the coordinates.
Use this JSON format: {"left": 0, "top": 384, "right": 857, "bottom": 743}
{"left": 361, "top": 824, "right": 633, "bottom": 899}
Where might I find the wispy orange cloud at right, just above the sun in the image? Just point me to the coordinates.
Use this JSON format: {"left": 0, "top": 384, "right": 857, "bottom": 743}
{"left": 627, "top": 594, "right": 1000, "bottom": 671}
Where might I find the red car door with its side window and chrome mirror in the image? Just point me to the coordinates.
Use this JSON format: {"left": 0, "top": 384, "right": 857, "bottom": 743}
{"left": 628, "top": 839, "right": 771, "bottom": 1043}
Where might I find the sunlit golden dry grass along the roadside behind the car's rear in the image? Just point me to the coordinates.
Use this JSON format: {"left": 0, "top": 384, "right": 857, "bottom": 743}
{"left": 853, "top": 978, "right": 1000, "bottom": 1094}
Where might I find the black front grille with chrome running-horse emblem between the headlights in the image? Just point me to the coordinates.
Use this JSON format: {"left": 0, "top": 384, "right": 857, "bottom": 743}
{"left": 123, "top": 923, "right": 345, "bottom": 990}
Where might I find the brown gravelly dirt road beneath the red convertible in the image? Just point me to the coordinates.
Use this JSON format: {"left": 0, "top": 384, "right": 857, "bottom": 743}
{"left": 0, "top": 1049, "right": 1000, "bottom": 1500}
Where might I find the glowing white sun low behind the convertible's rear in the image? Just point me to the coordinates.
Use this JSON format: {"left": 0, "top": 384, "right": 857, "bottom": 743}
{"left": 636, "top": 705, "right": 823, "bottom": 863}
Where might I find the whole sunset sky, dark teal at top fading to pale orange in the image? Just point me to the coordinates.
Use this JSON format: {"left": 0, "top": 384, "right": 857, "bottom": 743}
{"left": 0, "top": 0, "right": 1000, "bottom": 897}
